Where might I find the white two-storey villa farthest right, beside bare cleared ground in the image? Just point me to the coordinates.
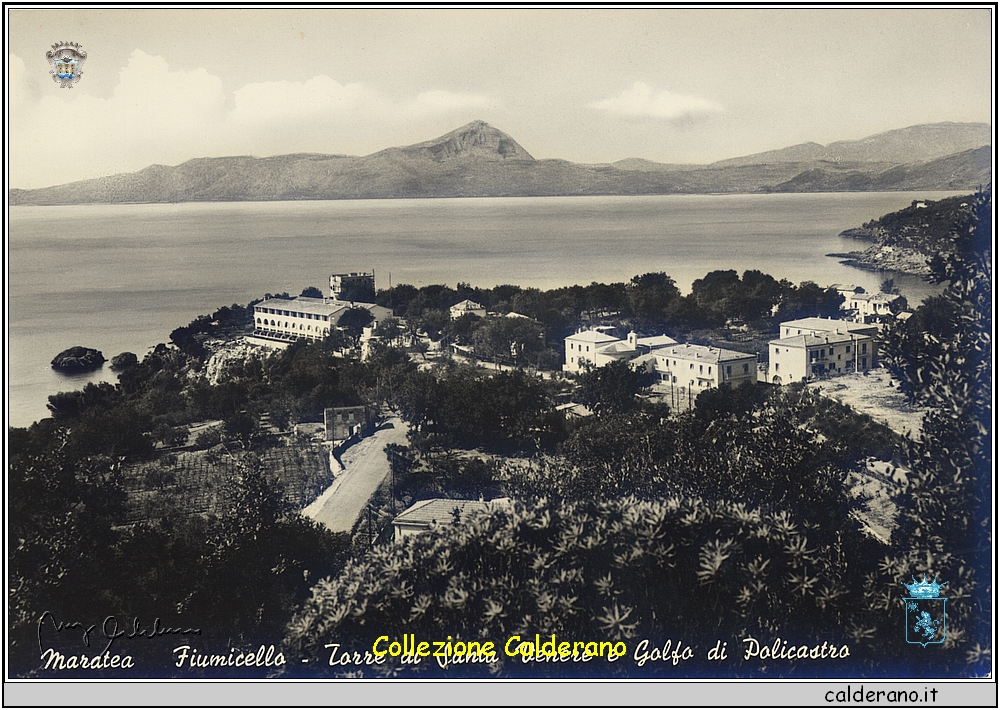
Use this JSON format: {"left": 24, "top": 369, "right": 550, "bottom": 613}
{"left": 768, "top": 318, "right": 877, "bottom": 385}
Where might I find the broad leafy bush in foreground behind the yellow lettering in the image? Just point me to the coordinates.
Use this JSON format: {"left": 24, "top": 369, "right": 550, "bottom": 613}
{"left": 283, "top": 497, "right": 868, "bottom": 677}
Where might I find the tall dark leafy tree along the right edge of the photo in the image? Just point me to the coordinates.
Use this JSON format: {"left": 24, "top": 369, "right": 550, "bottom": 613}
{"left": 870, "top": 186, "right": 995, "bottom": 677}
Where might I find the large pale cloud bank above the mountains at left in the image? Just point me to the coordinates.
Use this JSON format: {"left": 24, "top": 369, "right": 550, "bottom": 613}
{"left": 8, "top": 50, "right": 495, "bottom": 188}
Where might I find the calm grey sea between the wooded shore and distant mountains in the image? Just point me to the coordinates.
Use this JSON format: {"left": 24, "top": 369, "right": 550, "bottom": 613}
{"left": 6, "top": 192, "right": 956, "bottom": 426}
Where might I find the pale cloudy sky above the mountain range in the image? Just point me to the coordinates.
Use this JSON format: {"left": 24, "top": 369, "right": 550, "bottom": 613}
{"left": 5, "top": 7, "right": 995, "bottom": 188}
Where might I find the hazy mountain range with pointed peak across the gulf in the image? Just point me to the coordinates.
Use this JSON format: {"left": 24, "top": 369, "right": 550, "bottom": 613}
{"left": 8, "top": 121, "right": 992, "bottom": 205}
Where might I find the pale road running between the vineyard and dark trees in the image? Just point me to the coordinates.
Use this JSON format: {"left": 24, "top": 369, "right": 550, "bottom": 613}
{"left": 302, "top": 417, "right": 407, "bottom": 532}
